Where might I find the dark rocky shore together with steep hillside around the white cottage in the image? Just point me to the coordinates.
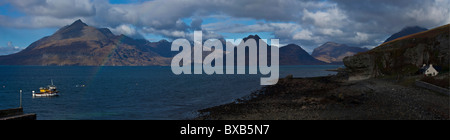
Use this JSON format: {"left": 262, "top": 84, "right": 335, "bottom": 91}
{"left": 196, "top": 24, "right": 450, "bottom": 120}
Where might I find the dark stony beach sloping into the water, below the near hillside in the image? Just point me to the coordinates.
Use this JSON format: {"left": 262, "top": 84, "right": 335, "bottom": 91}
{"left": 194, "top": 76, "right": 450, "bottom": 120}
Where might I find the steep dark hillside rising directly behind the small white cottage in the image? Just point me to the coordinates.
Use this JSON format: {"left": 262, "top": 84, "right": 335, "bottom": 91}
{"left": 344, "top": 24, "right": 450, "bottom": 80}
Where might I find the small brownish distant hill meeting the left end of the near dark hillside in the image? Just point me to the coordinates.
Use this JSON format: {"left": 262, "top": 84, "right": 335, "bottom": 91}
{"left": 311, "top": 42, "right": 368, "bottom": 64}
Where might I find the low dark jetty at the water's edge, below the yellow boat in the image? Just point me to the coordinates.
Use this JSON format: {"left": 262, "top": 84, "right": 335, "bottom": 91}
{"left": 0, "top": 107, "right": 36, "bottom": 120}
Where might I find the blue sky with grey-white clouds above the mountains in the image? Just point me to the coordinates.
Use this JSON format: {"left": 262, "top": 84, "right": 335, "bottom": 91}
{"left": 0, "top": 0, "right": 450, "bottom": 55}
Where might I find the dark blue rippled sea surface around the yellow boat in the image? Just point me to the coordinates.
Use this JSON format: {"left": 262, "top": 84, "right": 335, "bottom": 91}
{"left": 0, "top": 66, "right": 342, "bottom": 120}
